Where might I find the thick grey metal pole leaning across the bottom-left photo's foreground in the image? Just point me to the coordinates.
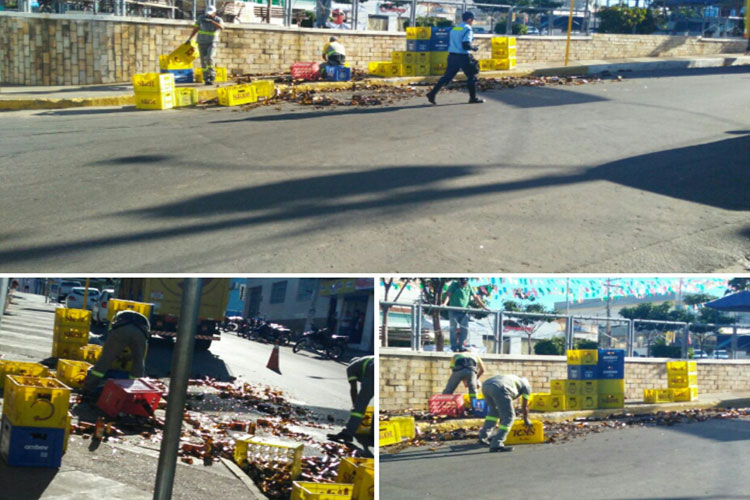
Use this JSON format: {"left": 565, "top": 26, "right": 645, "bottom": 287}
{"left": 154, "top": 278, "right": 203, "bottom": 500}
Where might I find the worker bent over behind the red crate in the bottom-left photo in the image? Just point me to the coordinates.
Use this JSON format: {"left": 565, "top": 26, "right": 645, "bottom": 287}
{"left": 83, "top": 310, "right": 151, "bottom": 394}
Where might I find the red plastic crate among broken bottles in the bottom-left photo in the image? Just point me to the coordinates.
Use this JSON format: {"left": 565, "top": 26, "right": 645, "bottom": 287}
{"left": 96, "top": 379, "right": 161, "bottom": 417}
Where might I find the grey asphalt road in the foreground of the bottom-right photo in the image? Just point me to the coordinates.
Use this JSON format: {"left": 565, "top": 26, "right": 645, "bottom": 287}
{"left": 380, "top": 419, "right": 750, "bottom": 500}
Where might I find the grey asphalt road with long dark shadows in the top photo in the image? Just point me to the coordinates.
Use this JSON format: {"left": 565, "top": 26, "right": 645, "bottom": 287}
{"left": 0, "top": 67, "right": 750, "bottom": 273}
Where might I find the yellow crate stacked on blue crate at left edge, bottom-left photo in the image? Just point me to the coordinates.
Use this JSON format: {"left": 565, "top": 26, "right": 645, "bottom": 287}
{"left": 0, "top": 375, "right": 70, "bottom": 468}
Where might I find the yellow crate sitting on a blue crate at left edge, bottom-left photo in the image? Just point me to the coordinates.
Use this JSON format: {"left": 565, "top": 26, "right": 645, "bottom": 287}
{"left": 3, "top": 375, "right": 70, "bottom": 429}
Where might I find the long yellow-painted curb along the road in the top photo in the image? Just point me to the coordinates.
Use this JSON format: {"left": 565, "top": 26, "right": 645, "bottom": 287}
{"left": 0, "top": 54, "right": 750, "bottom": 111}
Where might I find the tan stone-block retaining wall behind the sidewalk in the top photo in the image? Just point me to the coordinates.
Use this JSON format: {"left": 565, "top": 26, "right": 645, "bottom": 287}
{"left": 0, "top": 12, "right": 744, "bottom": 85}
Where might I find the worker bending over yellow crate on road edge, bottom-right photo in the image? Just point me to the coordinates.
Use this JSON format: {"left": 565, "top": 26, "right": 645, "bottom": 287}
{"left": 479, "top": 375, "right": 531, "bottom": 452}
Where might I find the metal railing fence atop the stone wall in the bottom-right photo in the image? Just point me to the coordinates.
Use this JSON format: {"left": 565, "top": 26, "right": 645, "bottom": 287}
{"left": 380, "top": 301, "right": 750, "bottom": 359}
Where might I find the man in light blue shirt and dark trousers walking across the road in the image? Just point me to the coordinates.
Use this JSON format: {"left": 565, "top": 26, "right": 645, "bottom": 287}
{"left": 427, "top": 11, "right": 484, "bottom": 104}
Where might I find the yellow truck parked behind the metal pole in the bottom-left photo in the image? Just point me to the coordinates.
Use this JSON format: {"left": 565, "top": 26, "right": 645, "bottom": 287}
{"left": 117, "top": 278, "right": 230, "bottom": 351}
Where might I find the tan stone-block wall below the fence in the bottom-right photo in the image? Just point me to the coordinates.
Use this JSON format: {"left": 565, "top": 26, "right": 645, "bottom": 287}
{"left": 379, "top": 349, "right": 750, "bottom": 410}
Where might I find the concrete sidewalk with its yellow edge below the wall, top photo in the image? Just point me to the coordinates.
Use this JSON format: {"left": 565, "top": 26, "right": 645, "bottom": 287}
{"left": 0, "top": 53, "right": 750, "bottom": 110}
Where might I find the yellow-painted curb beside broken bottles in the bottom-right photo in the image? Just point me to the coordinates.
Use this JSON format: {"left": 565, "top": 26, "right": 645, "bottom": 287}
{"left": 416, "top": 398, "right": 750, "bottom": 432}
